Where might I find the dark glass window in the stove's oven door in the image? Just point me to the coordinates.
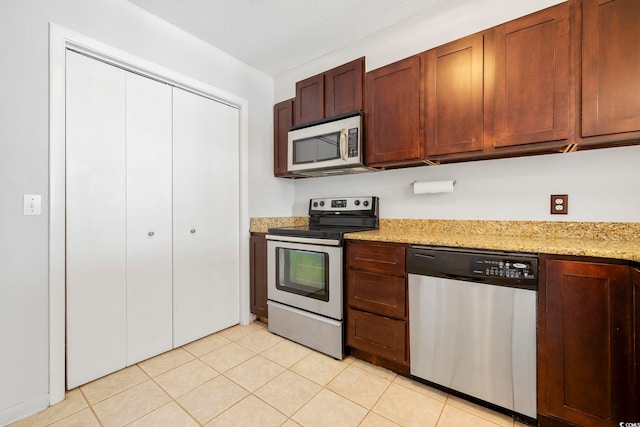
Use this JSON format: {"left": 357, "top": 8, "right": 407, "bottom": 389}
{"left": 276, "top": 248, "right": 329, "bottom": 301}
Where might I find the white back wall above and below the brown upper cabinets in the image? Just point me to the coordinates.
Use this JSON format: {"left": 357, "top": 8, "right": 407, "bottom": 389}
{"left": 274, "top": 0, "right": 640, "bottom": 222}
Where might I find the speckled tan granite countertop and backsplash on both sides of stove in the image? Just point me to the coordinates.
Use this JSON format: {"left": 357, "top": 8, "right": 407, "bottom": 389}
{"left": 250, "top": 217, "right": 640, "bottom": 262}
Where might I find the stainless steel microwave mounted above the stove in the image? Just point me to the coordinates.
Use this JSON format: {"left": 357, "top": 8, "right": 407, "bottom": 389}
{"left": 287, "top": 113, "right": 374, "bottom": 177}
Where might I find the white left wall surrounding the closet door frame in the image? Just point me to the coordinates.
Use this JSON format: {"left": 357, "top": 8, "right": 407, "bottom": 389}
{"left": 0, "top": 0, "right": 293, "bottom": 425}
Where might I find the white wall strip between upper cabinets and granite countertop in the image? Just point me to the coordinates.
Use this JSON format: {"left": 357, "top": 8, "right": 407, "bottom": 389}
{"left": 294, "top": 146, "right": 640, "bottom": 222}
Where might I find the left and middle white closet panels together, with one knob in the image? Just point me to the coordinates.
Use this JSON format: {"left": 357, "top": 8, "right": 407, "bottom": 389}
{"left": 66, "top": 51, "right": 173, "bottom": 388}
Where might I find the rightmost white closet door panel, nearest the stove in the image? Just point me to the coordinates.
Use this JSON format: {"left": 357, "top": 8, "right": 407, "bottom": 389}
{"left": 173, "top": 88, "right": 240, "bottom": 347}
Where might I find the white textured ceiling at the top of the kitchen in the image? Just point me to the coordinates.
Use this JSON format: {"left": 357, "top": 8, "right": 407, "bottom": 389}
{"left": 129, "top": 0, "right": 456, "bottom": 76}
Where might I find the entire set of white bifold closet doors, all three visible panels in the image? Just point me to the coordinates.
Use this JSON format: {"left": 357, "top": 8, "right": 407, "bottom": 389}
{"left": 66, "top": 51, "right": 240, "bottom": 389}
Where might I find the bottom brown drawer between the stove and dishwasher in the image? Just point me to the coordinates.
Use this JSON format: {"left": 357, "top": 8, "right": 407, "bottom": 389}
{"left": 347, "top": 308, "right": 407, "bottom": 365}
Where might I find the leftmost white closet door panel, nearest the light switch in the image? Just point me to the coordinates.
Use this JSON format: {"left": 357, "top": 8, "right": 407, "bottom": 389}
{"left": 66, "top": 51, "right": 126, "bottom": 389}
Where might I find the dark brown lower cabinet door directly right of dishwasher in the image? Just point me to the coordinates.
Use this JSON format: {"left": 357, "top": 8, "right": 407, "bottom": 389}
{"left": 539, "top": 260, "right": 633, "bottom": 426}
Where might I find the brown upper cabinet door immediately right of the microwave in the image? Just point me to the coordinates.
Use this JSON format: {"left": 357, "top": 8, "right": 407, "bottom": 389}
{"left": 365, "top": 55, "right": 424, "bottom": 167}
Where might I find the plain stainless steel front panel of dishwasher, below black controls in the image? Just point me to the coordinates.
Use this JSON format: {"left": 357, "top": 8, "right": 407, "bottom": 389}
{"left": 409, "top": 274, "right": 537, "bottom": 418}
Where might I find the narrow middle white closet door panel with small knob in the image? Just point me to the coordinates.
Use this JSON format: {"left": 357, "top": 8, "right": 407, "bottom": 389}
{"left": 126, "top": 73, "right": 173, "bottom": 365}
